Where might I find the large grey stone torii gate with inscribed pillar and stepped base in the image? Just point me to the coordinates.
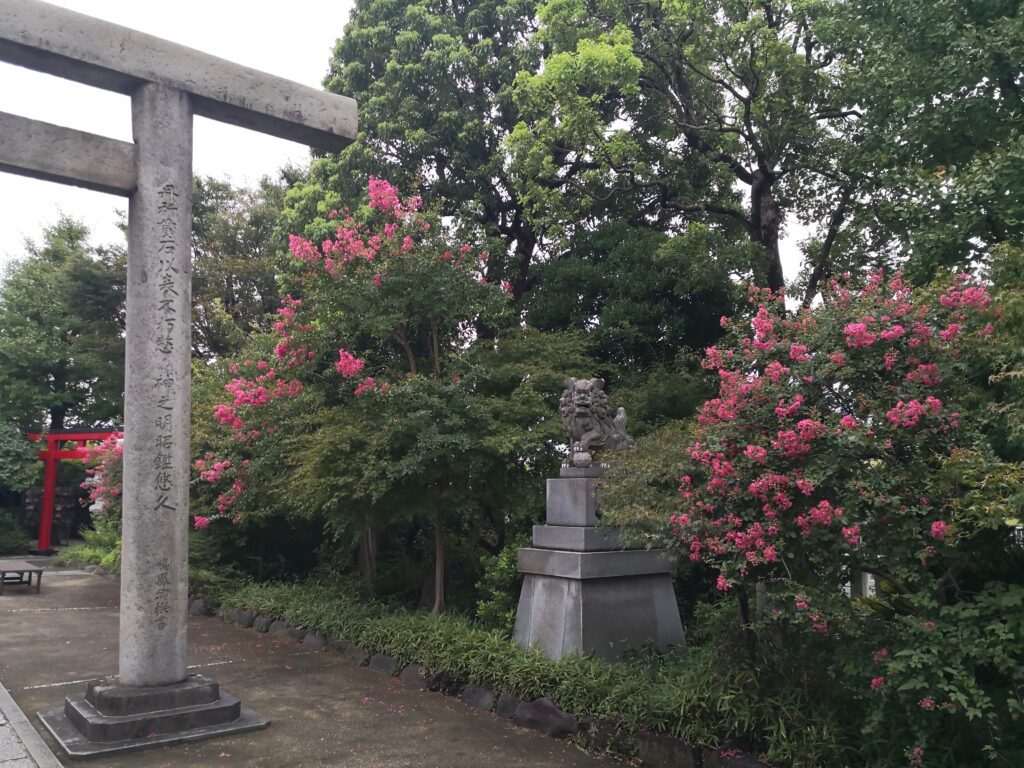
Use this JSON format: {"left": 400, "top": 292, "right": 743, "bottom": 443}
{"left": 0, "top": 0, "right": 356, "bottom": 756}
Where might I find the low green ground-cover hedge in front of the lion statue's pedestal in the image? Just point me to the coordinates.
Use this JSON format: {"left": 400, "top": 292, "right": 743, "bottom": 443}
{"left": 214, "top": 582, "right": 839, "bottom": 766}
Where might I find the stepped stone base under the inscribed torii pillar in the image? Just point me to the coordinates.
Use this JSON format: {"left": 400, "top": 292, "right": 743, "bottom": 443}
{"left": 39, "top": 675, "right": 270, "bottom": 758}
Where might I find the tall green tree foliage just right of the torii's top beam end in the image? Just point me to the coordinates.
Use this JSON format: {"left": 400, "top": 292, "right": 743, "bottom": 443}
{"left": 290, "top": 0, "right": 540, "bottom": 297}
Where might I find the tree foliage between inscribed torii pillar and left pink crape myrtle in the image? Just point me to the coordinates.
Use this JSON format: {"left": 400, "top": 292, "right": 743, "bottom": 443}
{"left": 191, "top": 177, "right": 287, "bottom": 358}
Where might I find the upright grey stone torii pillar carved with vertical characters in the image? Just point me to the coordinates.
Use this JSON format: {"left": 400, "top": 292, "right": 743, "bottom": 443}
{"left": 118, "top": 83, "right": 193, "bottom": 686}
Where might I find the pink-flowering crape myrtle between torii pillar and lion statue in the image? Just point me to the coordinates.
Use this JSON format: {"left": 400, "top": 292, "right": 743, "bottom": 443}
{"left": 196, "top": 178, "right": 585, "bottom": 611}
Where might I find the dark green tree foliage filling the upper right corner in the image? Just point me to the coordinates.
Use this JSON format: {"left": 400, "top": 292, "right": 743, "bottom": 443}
{"left": 828, "top": 0, "right": 1024, "bottom": 283}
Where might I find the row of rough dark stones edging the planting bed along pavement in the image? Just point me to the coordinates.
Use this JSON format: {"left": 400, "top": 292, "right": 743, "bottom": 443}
{"left": 195, "top": 596, "right": 771, "bottom": 768}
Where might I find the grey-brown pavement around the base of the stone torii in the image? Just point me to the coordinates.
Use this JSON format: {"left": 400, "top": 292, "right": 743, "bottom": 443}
{"left": 0, "top": 568, "right": 622, "bottom": 768}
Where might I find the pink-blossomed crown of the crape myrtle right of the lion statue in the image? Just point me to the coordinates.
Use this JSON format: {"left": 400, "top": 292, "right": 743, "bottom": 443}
{"left": 666, "top": 270, "right": 997, "bottom": 703}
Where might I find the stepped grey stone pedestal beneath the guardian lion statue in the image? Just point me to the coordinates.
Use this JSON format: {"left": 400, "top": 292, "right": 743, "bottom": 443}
{"left": 515, "top": 467, "right": 685, "bottom": 658}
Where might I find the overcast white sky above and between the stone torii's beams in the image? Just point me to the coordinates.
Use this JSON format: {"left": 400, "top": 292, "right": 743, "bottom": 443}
{"left": 0, "top": 0, "right": 352, "bottom": 269}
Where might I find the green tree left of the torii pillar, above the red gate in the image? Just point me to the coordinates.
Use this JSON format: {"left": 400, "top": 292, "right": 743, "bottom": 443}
{"left": 0, "top": 218, "right": 125, "bottom": 430}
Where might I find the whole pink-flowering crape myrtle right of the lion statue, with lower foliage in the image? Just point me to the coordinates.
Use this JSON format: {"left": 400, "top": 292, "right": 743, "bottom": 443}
{"left": 605, "top": 270, "right": 1024, "bottom": 765}
